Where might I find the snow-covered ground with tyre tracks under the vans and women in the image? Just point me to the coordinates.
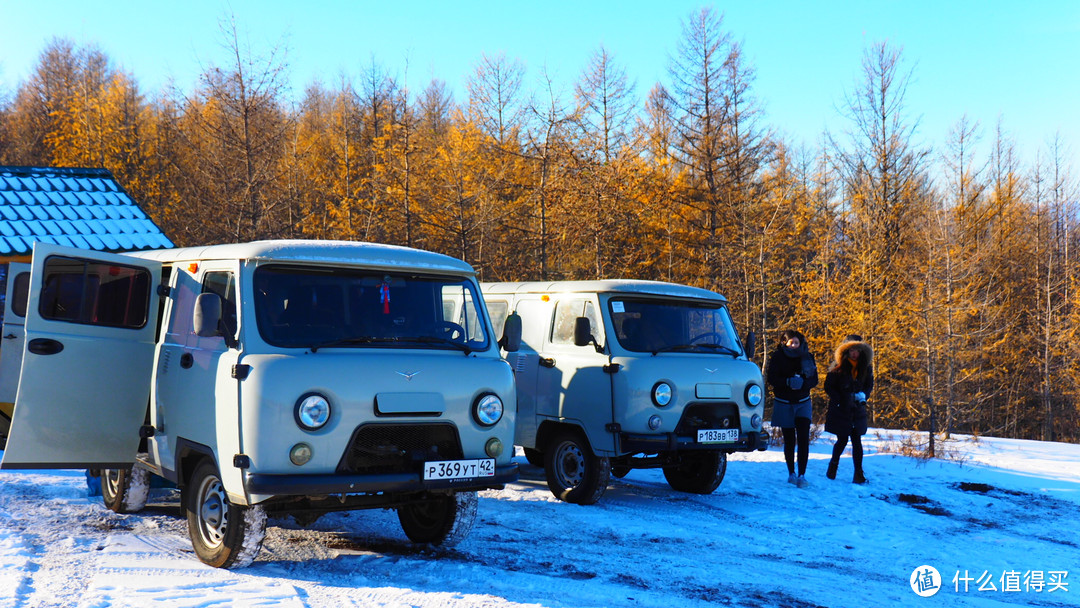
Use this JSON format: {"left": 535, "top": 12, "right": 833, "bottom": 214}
{"left": 0, "top": 430, "right": 1080, "bottom": 608}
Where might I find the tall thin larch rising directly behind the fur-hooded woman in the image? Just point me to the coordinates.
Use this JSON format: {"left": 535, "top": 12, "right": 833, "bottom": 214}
{"left": 833, "top": 42, "right": 929, "bottom": 429}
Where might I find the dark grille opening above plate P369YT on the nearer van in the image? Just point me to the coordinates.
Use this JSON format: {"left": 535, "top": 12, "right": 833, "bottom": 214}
{"left": 337, "top": 423, "right": 462, "bottom": 475}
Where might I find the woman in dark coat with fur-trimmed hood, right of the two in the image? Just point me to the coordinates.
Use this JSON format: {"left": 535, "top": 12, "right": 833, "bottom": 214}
{"left": 825, "top": 336, "right": 874, "bottom": 484}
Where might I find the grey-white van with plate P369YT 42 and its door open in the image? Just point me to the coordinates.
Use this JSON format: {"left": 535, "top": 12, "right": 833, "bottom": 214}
{"left": 2, "top": 241, "right": 519, "bottom": 568}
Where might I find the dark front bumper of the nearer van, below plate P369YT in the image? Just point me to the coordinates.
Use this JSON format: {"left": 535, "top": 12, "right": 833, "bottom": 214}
{"left": 246, "top": 463, "right": 517, "bottom": 496}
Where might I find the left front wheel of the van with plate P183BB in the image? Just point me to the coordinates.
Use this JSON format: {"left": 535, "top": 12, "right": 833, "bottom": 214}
{"left": 544, "top": 431, "right": 611, "bottom": 504}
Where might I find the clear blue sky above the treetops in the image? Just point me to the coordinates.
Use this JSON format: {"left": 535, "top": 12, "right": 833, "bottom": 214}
{"left": 0, "top": 0, "right": 1080, "bottom": 171}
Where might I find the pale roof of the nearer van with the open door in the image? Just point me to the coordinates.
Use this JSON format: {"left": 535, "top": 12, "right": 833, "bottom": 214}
{"left": 126, "top": 240, "right": 473, "bottom": 274}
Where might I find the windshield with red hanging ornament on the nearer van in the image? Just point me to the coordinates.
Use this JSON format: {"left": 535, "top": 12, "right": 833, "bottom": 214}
{"left": 254, "top": 265, "right": 488, "bottom": 353}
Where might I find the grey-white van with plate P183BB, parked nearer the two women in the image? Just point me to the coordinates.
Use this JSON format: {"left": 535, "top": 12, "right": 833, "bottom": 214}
{"left": 481, "top": 280, "right": 769, "bottom": 504}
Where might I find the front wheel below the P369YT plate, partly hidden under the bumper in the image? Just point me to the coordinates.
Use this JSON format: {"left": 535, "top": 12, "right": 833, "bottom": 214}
{"left": 397, "top": 491, "right": 476, "bottom": 546}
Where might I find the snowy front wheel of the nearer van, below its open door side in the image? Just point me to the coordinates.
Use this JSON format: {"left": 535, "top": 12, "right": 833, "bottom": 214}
{"left": 181, "top": 460, "right": 267, "bottom": 568}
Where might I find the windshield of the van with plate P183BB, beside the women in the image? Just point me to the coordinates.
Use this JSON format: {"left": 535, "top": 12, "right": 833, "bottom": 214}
{"left": 608, "top": 298, "right": 743, "bottom": 356}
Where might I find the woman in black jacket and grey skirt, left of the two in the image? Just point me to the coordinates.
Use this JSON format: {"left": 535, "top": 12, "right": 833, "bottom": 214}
{"left": 765, "top": 329, "right": 818, "bottom": 488}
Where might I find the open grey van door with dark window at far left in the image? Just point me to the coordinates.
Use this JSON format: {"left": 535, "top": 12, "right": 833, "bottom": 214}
{"left": 0, "top": 243, "right": 161, "bottom": 469}
